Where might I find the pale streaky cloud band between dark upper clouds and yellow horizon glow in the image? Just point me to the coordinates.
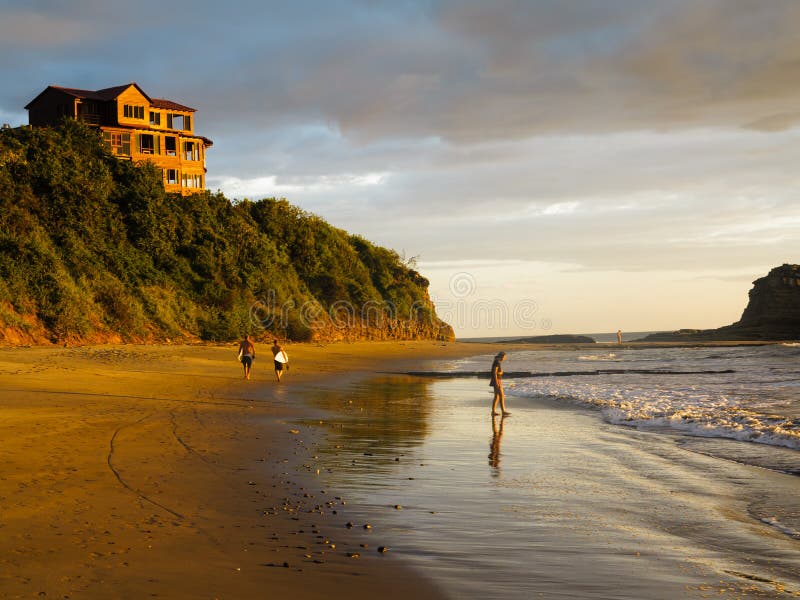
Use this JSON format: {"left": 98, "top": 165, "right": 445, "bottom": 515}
{"left": 270, "top": 125, "right": 800, "bottom": 271}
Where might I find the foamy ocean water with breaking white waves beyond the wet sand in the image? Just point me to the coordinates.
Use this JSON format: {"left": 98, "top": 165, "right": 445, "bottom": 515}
{"left": 468, "top": 343, "right": 800, "bottom": 460}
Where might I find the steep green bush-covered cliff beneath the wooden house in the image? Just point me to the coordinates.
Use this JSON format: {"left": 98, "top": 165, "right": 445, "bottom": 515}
{"left": 0, "top": 121, "right": 452, "bottom": 341}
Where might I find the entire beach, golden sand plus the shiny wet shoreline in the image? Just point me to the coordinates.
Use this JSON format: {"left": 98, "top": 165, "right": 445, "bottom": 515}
{"left": 0, "top": 342, "right": 800, "bottom": 600}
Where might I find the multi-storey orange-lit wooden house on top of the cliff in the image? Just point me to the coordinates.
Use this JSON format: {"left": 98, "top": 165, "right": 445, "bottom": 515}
{"left": 25, "top": 83, "right": 212, "bottom": 195}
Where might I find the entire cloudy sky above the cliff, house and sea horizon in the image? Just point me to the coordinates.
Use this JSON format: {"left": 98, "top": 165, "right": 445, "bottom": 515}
{"left": 0, "top": 0, "right": 800, "bottom": 337}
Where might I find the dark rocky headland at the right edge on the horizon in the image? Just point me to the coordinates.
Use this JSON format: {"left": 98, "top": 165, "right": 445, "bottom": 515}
{"left": 644, "top": 264, "right": 800, "bottom": 342}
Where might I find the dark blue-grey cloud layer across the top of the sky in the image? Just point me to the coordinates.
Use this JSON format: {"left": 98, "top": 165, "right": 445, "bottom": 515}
{"left": 6, "top": 0, "right": 800, "bottom": 139}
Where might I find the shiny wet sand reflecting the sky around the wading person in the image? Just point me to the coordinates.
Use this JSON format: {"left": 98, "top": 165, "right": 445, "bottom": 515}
{"left": 294, "top": 376, "right": 800, "bottom": 600}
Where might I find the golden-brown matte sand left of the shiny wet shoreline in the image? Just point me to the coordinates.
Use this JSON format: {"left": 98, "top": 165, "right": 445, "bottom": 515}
{"left": 0, "top": 342, "right": 500, "bottom": 599}
